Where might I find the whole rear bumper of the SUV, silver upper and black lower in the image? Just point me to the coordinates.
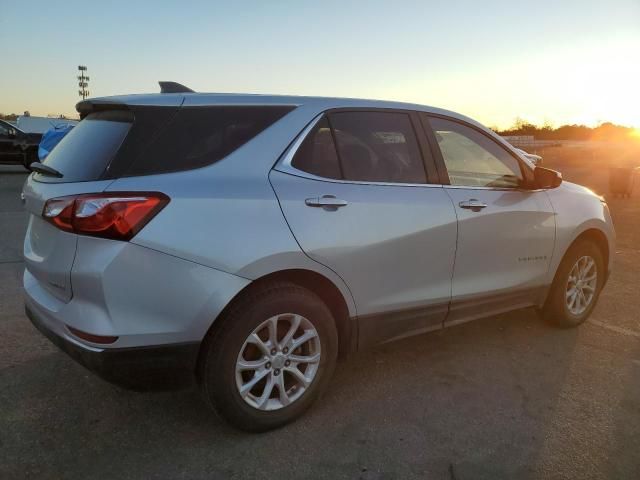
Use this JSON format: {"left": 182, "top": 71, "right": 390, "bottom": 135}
{"left": 23, "top": 240, "right": 250, "bottom": 390}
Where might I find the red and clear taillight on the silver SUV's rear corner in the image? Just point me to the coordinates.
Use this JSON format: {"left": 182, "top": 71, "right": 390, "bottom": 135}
{"left": 42, "top": 192, "right": 169, "bottom": 240}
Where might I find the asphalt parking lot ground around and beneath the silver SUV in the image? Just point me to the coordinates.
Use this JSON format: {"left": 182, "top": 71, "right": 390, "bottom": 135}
{"left": 0, "top": 165, "right": 640, "bottom": 480}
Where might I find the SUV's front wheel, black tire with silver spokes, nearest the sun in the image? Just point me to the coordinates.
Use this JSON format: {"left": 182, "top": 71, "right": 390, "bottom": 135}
{"left": 541, "top": 240, "right": 606, "bottom": 328}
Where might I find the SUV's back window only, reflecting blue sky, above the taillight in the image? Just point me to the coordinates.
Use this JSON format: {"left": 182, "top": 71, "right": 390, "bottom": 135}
{"left": 35, "top": 111, "right": 133, "bottom": 182}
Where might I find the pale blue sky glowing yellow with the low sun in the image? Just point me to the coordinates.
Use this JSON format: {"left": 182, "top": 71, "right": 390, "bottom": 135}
{"left": 0, "top": 0, "right": 640, "bottom": 127}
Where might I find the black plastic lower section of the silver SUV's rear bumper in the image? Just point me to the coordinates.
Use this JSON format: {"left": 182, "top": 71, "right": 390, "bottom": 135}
{"left": 25, "top": 305, "right": 200, "bottom": 391}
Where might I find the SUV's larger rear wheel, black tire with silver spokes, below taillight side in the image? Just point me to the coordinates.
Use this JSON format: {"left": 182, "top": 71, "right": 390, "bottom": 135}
{"left": 198, "top": 282, "right": 338, "bottom": 432}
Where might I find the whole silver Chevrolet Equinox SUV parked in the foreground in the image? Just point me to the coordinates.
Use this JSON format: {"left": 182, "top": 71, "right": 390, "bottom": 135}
{"left": 24, "top": 85, "right": 614, "bottom": 431}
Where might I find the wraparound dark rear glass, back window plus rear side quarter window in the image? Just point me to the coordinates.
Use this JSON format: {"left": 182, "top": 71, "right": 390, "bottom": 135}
{"left": 35, "top": 106, "right": 294, "bottom": 182}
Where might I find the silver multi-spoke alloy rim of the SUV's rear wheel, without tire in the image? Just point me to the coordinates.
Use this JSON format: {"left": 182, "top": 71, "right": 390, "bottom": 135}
{"left": 236, "top": 313, "right": 321, "bottom": 410}
